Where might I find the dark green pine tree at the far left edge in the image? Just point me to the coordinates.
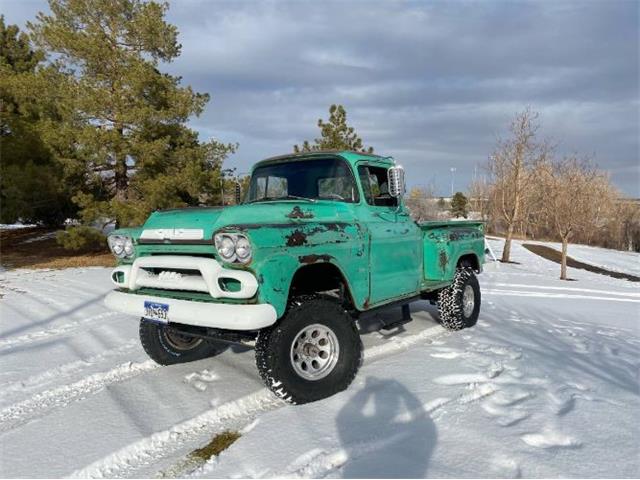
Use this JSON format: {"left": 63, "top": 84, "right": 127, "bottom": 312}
{"left": 0, "top": 16, "right": 75, "bottom": 225}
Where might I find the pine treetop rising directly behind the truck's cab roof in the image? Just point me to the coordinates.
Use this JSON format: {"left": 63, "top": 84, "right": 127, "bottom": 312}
{"left": 293, "top": 105, "right": 373, "bottom": 153}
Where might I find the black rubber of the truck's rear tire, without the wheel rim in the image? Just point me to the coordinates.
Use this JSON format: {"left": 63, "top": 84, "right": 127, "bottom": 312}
{"left": 438, "top": 267, "right": 480, "bottom": 330}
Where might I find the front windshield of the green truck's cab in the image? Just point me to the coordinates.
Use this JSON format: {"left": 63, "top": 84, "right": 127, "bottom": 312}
{"left": 247, "top": 158, "right": 358, "bottom": 203}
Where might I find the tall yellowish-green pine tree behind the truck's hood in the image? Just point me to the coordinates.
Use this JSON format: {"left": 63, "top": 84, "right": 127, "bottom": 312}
{"left": 29, "top": 0, "right": 234, "bottom": 225}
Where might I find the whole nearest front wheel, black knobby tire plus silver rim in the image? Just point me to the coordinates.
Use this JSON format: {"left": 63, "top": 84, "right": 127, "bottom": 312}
{"left": 256, "top": 296, "right": 362, "bottom": 404}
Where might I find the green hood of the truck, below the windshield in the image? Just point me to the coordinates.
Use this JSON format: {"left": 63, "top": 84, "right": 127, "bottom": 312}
{"left": 143, "top": 200, "right": 352, "bottom": 239}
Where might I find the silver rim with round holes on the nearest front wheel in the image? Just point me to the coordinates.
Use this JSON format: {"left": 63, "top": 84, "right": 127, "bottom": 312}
{"left": 290, "top": 323, "right": 340, "bottom": 381}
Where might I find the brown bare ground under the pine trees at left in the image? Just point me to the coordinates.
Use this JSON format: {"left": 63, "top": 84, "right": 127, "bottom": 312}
{"left": 0, "top": 227, "right": 116, "bottom": 269}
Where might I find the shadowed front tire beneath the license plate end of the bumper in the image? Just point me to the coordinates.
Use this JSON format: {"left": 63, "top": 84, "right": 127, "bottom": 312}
{"left": 139, "top": 318, "right": 226, "bottom": 365}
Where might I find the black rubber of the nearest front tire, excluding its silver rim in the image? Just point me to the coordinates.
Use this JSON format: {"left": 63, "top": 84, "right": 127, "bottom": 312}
{"left": 256, "top": 295, "right": 363, "bottom": 404}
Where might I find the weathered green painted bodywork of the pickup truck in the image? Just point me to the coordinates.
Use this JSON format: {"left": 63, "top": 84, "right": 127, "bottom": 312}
{"left": 114, "top": 152, "right": 484, "bottom": 316}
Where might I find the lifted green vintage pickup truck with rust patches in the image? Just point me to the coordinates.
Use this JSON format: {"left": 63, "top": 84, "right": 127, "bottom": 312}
{"left": 105, "top": 152, "right": 484, "bottom": 403}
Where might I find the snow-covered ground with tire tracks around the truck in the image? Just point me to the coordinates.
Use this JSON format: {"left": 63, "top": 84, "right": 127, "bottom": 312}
{"left": 0, "top": 242, "right": 640, "bottom": 477}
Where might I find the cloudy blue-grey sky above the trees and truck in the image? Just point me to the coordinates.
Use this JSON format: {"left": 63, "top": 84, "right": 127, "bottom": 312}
{"left": 0, "top": 0, "right": 640, "bottom": 197}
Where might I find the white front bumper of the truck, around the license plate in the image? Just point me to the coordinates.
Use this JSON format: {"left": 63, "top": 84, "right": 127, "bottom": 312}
{"left": 104, "top": 291, "right": 277, "bottom": 330}
